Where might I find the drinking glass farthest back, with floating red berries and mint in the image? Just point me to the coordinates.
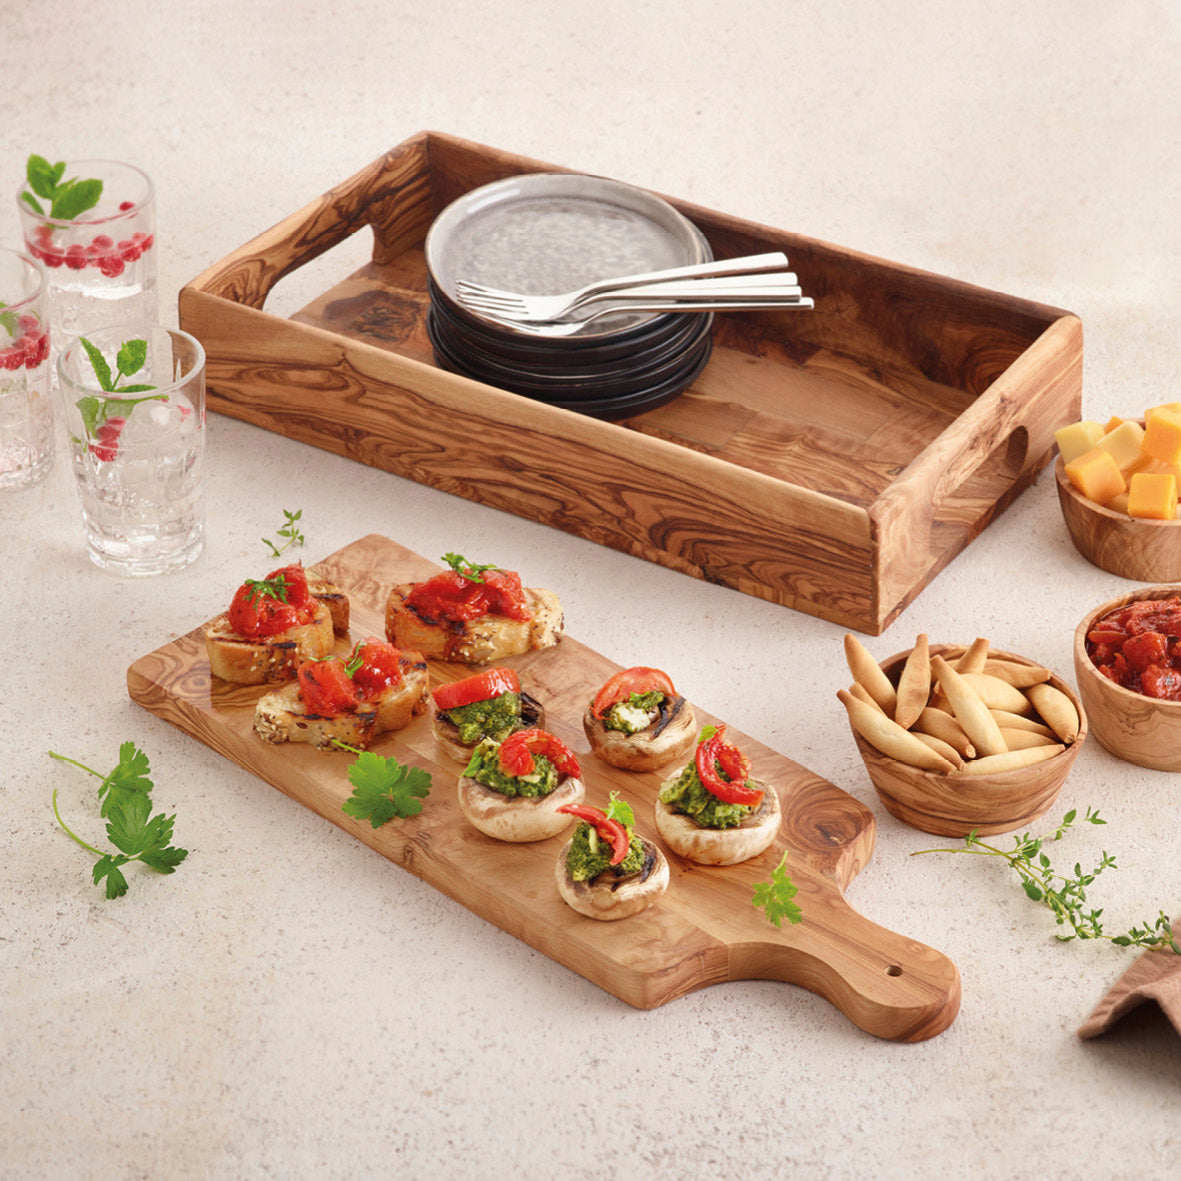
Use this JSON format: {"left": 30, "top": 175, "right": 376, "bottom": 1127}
{"left": 17, "top": 159, "right": 157, "bottom": 342}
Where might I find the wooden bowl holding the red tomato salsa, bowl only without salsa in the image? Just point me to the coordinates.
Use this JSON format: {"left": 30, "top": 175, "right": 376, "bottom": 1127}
{"left": 1075, "top": 586, "right": 1181, "bottom": 771}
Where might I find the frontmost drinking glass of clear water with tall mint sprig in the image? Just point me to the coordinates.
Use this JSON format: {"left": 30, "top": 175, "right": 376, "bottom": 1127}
{"left": 58, "top": 324, "right": 205, "bottom": 575}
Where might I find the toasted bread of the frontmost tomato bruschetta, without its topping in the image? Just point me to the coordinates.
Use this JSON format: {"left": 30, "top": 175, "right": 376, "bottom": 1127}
{"left": 254, "top": 652, "right": 430, "bottom": 750}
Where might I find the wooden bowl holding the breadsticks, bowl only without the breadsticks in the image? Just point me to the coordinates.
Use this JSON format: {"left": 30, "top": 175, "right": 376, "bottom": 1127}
{"left": 853, "top": 645, "right": 1087, "bottom": 836}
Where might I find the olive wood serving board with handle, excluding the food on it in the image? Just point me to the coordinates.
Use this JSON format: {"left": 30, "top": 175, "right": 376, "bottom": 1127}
{"left": 128, "top": 535, "right": 960, "bottom": 1042}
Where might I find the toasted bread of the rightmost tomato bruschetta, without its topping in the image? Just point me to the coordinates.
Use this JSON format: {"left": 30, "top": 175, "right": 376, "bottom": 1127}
{"left": 385, "top": 582, "right": 562, "bottom": 665}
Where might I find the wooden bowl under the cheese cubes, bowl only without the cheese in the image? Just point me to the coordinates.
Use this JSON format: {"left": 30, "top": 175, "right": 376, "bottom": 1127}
{"left": 1053, "top": 455, "right": 1181, "bottom": 582}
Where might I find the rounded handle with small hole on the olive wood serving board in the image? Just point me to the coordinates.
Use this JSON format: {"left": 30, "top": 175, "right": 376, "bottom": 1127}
{"left": 731, "top": 893, "right": 960, "bottom": 1042}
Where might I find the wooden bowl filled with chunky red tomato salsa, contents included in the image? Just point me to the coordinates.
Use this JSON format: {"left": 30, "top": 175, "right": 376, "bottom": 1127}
{"left": 1075, "top": 585, "right": 1181, "bottom": 771}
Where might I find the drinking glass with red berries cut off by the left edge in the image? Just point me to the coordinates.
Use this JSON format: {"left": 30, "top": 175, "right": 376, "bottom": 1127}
{"left": 0, "top": 249, "right": 53, "bottom": 489}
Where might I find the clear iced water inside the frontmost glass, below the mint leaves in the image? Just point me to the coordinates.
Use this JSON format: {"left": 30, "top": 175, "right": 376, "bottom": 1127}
{"left": 70, "top": 393, "right": 204, "bottom": 574}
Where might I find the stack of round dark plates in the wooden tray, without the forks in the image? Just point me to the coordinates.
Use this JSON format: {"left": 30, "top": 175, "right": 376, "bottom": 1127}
{"left": 425, "top": 172, "right": 713, "bottom": 418}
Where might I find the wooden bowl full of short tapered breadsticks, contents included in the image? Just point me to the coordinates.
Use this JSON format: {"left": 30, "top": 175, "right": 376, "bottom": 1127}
{"left": 837, "top": 634, "right": 1087, "bottom": 836}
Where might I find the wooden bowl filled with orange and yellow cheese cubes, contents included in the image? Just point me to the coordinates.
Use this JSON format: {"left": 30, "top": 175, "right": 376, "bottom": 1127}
{"left": 1055, "top": 402, "right": 1181, "bottom": 582}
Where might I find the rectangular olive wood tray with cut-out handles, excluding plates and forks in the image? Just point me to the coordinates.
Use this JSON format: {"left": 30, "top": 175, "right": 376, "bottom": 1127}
{"left": 180, "top": 132, "right": 1082, "bottom": 633}
